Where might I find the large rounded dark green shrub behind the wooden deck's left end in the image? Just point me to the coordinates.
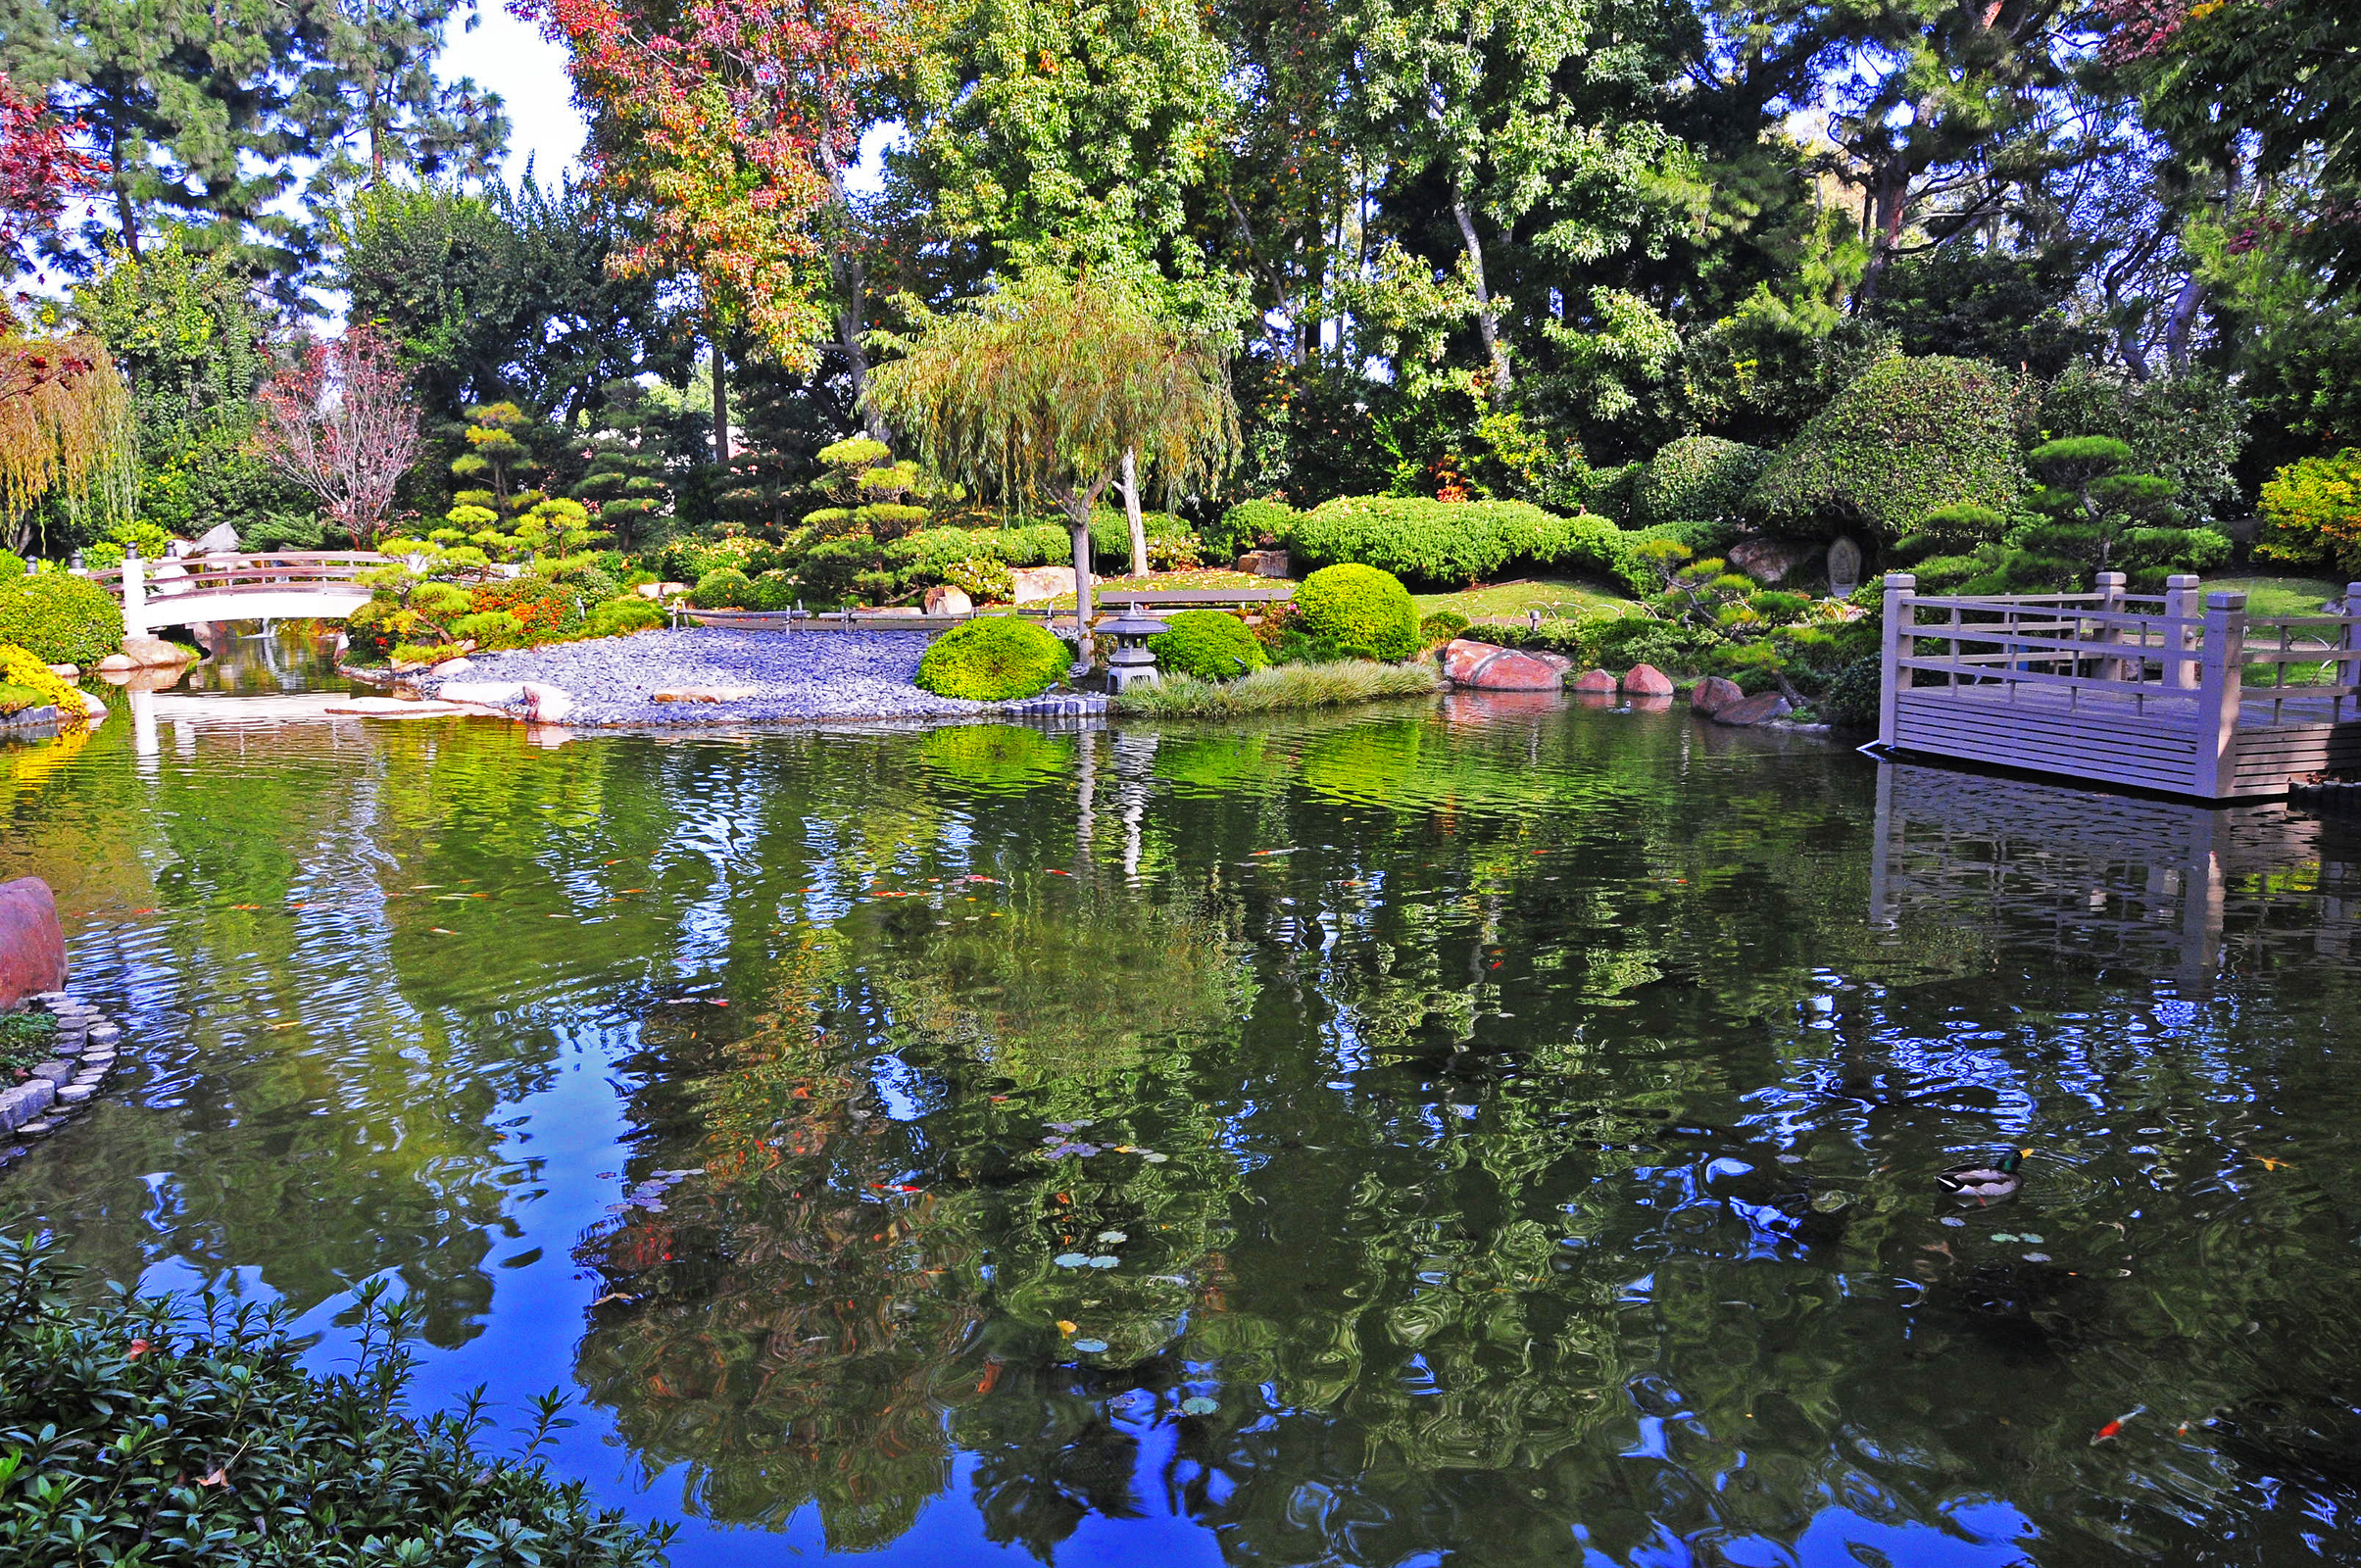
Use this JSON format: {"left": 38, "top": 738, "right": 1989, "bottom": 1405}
{"left": 1743, "top": 359, "right": 2031, "bottom": 543}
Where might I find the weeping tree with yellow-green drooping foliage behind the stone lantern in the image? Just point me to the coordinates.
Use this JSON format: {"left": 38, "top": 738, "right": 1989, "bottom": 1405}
{"left": 869, "top": 270, "right": 1237, "bottom": 662}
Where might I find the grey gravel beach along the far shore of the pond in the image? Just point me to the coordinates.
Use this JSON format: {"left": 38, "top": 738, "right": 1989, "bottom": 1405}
{"left": 418, "top": 628, "right": 994, "bottom": 727}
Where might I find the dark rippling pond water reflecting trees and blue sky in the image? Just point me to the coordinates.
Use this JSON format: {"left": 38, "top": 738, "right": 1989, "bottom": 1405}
{"left": 0, "top": 642, "right": 2361, "bottom": 1568}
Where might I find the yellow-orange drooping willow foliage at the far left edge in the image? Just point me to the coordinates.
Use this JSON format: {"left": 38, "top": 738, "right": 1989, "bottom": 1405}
{"left": 0, "top": 335, "right": 139, "bottom": 555}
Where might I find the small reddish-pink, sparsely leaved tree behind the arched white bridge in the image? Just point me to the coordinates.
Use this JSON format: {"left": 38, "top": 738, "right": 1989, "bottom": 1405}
{"left": 255, "top": 323, "right": 418, "bottom": 546}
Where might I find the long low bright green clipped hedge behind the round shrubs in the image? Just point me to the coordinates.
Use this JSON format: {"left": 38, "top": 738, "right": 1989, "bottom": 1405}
{"left": 1287, "top": 496, "right": 1639, "bottom": 588}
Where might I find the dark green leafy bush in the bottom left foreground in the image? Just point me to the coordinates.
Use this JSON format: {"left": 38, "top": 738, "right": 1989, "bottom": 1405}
{"left": 0, "top": 1238, "right": 668, "bottom": 1568}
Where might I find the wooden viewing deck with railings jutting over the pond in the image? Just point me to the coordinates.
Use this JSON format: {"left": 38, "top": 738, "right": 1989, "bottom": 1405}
{"left": 1877, "top": 571, "right": 2361, "bottom": 801}
